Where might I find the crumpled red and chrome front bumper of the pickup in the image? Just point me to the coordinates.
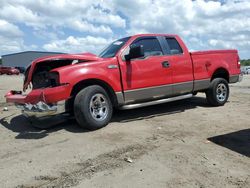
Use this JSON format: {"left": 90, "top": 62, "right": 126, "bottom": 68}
{"left": 5, "top": 84, "right": 70, "bottom": 127}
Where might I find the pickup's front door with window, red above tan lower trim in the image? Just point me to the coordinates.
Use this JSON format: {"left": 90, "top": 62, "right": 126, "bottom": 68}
{"left": 119, "top": 36, "right": 172, "bottom": 103}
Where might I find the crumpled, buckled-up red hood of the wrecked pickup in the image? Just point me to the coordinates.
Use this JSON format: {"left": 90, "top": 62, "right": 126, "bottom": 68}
{"left": 23, "top": 53, "right": 103, "bottom": 91}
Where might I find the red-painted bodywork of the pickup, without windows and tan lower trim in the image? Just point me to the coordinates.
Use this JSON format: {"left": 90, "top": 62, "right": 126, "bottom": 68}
{"left": 6, "top": 34, "right": 240, "bottom": 104}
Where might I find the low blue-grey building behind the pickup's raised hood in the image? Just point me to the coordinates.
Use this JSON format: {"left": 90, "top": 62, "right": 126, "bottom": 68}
{"left": 2, "top": 51, "right": 62, "bottom": 68}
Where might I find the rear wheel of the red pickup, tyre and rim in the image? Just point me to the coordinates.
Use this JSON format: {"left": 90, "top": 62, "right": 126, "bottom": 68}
{"left": 206, "top": 78, "right": 229, "bottom": 106}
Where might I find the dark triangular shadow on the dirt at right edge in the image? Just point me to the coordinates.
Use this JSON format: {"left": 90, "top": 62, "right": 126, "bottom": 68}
{"left": 208, "top": 129, "right": 250, "bottom": 157}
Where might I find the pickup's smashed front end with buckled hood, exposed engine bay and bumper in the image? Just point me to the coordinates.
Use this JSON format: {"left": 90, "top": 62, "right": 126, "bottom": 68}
{"left": 5, "top": 53, "right": 98, "bottom": 126}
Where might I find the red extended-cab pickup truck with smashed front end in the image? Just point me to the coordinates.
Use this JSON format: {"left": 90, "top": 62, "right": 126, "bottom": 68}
{"left": 6, "top": 34, "right": 241, "bottom": 130}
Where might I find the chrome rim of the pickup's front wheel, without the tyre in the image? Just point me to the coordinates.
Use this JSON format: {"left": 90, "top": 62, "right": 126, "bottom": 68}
{"left": 89, "top": 93, "right": 109, "bottom": 121}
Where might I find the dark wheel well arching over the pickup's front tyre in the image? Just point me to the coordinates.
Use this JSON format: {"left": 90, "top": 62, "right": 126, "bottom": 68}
{"left": 71, "top": 79, "right": 118, "bottom": 106}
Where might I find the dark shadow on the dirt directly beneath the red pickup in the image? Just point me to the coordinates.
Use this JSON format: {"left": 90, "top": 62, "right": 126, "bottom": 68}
{"left": 0, "top": 97, "right": 210, "bottom": 139}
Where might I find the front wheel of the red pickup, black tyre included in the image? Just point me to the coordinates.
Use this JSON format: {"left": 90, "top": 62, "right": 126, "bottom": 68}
{"left": 74, "top": 85, "right": 113, "bottom": 130}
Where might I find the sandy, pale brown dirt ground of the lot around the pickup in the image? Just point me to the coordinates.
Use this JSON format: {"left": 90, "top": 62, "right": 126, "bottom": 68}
{"left": 0, "top": 76, "right": 250, "bottom": 188}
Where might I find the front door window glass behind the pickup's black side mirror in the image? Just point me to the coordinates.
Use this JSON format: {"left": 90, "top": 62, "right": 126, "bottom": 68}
{"left": 131, "top": 38, "right": 163, "bottom": 57}
